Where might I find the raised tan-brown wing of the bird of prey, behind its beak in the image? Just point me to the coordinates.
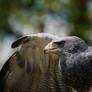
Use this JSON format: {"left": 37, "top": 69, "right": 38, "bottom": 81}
{"left": 0, "top": 33, "right": 72, "bottom": 92}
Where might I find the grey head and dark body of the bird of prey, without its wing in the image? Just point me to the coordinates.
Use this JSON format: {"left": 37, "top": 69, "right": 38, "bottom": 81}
{"left": 44, "top": 36, "right": 92, "bottom": 92}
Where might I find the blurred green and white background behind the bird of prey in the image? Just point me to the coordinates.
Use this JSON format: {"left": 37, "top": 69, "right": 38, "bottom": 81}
{"left": 0, "top": 0, "right": 92, "bottom": 67}
